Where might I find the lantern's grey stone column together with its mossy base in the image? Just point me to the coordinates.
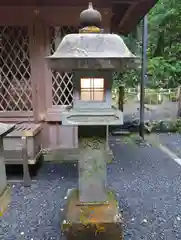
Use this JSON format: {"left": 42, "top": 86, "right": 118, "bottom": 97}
{"left": 62, "top": 126, "right": 122, "bottom": 240}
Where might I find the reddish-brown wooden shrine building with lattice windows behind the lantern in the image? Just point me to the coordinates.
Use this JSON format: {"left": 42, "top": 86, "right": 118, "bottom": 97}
{"left": 0, "top": 0, "right": 156, "bottom": 148}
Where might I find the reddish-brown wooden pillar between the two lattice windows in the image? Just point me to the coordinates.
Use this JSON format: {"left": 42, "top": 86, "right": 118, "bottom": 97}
{"left": 30, "top": 21, "right": 46, "bottom": 122}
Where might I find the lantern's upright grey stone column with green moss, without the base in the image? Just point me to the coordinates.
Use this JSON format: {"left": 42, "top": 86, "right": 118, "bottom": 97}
{"left": 78, "top": 126, "right": 107, "bottom": 204}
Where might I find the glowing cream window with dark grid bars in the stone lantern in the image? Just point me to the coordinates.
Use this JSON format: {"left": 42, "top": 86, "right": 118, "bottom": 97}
{"left": 80, "top": 78, "right": 104, "bottom": 101}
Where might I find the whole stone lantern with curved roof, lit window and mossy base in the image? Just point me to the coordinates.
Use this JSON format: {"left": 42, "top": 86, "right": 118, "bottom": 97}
{"left": 46, "top": 3, "right": 136, "bottom": 239}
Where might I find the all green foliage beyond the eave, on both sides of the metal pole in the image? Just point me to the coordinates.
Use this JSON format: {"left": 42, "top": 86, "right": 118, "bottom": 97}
{"left": 116, "top": 0, "right": 181, "bottom": 88}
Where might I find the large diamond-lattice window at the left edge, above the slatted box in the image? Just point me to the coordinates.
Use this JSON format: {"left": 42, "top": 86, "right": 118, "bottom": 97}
{"left": 0, "top": 26, "right": 32, "bottom": 111}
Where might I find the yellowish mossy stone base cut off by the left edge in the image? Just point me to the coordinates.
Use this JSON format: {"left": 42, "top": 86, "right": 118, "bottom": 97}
{"left": 0, "top": 186, "right": 11, "bottom": 217}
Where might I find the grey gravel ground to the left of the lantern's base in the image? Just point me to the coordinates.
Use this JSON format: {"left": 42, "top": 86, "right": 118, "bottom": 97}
{"left": 0, "top": 163, "right": 78, "bottom": 240}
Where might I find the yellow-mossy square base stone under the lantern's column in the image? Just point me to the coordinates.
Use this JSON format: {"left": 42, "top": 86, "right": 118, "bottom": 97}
{"left": 62, "top": 189, "right": 123, "bottom": 240}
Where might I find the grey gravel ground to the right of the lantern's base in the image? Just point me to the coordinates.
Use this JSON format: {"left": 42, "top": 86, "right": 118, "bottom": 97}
{"left": 108, "top": 135, "right": 181, "bottom": 240}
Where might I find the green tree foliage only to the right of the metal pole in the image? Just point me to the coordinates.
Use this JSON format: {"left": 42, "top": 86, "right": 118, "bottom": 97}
{"left": 148, "top": 0, "right": 181, "bottom": 88}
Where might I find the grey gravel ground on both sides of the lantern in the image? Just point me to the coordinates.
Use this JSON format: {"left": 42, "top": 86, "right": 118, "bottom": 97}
{"left": 0, "top": 137, "right": 181, "bottom": 240}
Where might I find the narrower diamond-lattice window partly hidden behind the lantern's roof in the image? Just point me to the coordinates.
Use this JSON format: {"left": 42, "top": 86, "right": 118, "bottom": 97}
{"left": 50, "top": 27, "right": 78, "bottom": 105}
